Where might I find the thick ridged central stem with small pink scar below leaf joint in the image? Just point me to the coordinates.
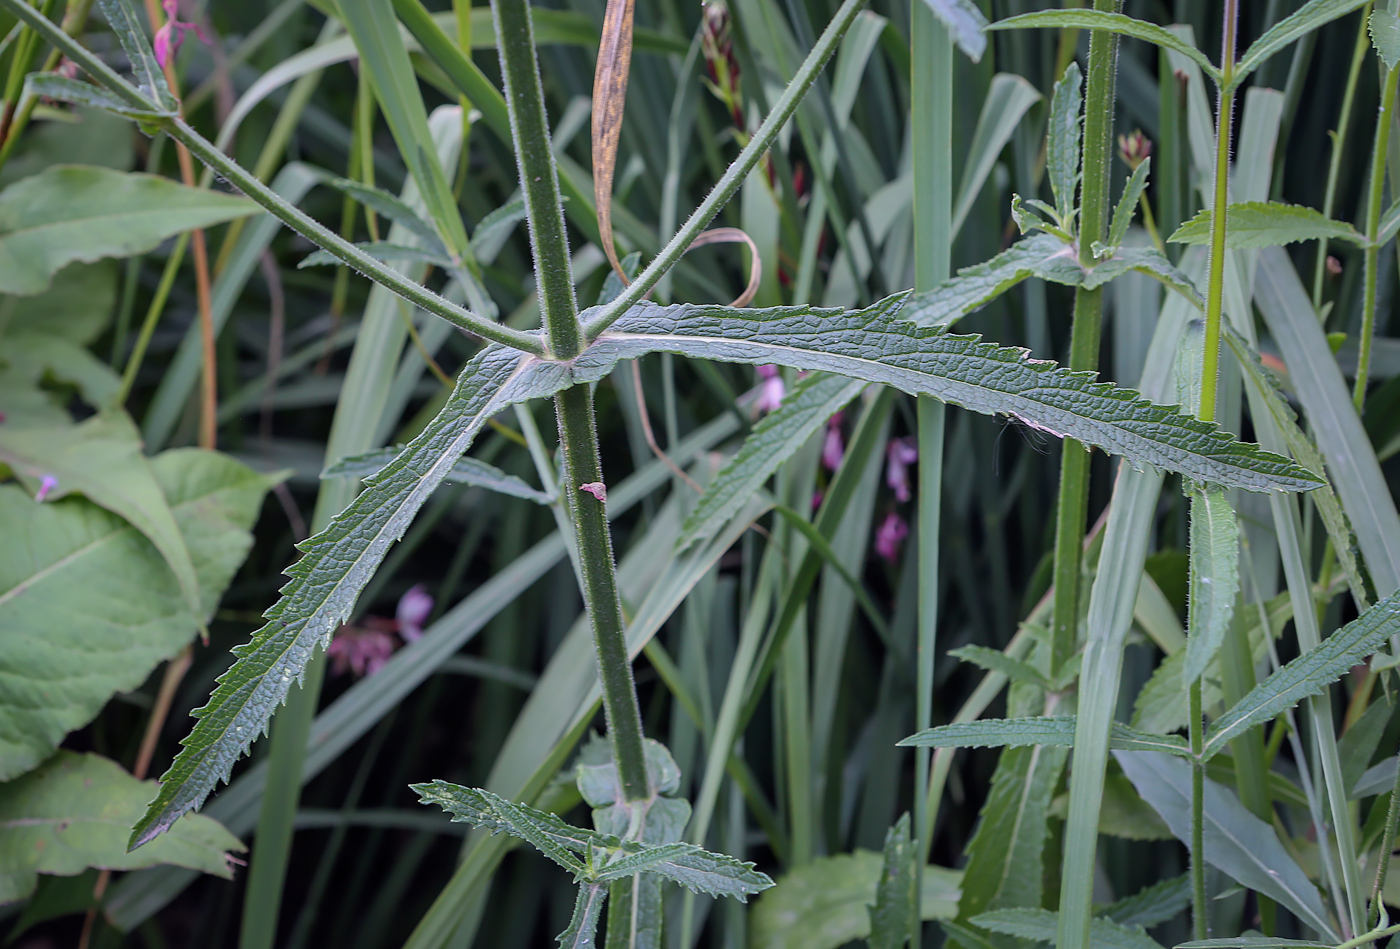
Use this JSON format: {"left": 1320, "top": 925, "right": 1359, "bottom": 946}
{"left": 491, "top": 0, "right": 651, "bottom": 801}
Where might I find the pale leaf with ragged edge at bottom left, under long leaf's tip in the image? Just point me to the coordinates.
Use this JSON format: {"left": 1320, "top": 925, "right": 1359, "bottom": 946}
{"left": 0, "top": 752, "right": 246, "bottom": 904}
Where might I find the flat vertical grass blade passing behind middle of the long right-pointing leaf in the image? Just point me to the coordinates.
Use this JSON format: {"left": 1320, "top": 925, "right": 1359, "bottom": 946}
{"left": 910, "top": 3, "right": 953, "bottom": 884}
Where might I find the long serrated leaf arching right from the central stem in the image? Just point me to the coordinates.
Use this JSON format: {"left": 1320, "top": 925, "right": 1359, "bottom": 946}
{"left": 573, "top": 294, "right": 1322, "bottom": 491}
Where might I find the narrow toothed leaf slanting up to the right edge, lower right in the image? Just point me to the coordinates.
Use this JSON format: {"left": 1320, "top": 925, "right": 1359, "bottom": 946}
{"left": 1203, "top": 591, "right": 1400, "bottom": 759}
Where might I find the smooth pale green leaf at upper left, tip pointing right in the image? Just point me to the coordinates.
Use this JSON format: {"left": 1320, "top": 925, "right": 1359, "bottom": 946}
{"left": 0, "top": 165, "right": 262, "bottom": 295}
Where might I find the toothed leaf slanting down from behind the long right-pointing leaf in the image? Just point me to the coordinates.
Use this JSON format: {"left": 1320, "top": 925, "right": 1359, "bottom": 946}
{"left": 676, "top": 372, "right": 865, "bottom": 549}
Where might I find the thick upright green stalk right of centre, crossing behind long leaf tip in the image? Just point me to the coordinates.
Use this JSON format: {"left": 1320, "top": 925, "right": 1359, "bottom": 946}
{"left": 1050, "top": 0, "right": 1119, "bottom": 675}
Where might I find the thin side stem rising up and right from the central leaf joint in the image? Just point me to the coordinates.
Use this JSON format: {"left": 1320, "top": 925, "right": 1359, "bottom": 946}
{"left": 579, "top": 0, "right": 865, "bottom": 339}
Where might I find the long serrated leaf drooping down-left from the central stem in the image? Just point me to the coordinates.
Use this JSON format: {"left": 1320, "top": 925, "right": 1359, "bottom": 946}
{"left": 132, "top": 346, "right": 568, "bottom": 847}
